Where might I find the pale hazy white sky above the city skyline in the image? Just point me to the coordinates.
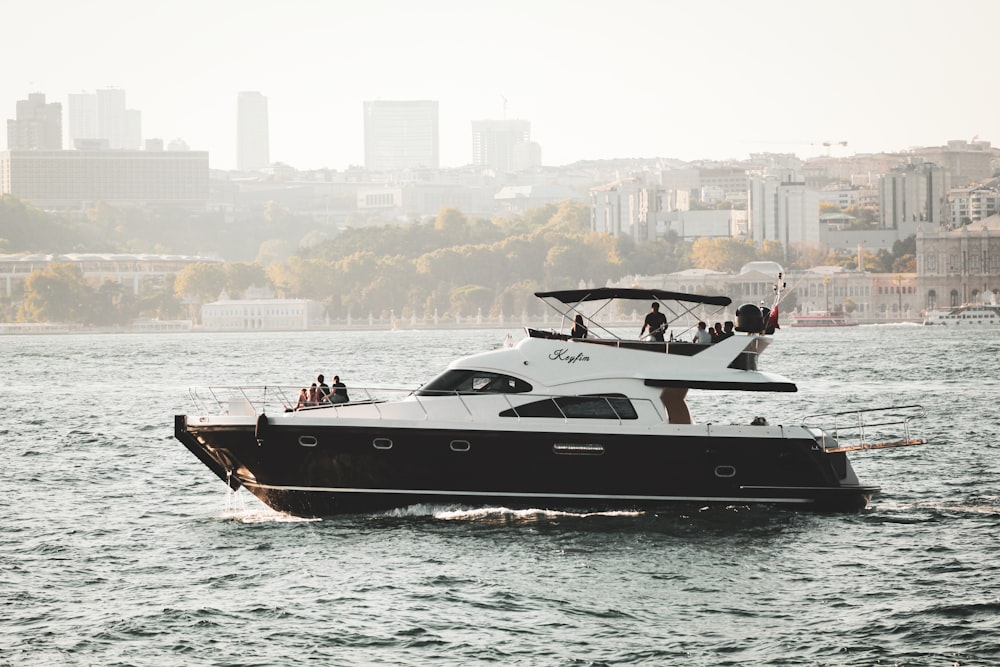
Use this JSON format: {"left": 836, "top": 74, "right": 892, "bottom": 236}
{"left": 0, "top": 0, "right": 1000, "bottom": 169}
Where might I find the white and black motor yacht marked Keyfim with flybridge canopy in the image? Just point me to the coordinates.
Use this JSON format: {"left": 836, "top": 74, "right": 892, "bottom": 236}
{"left": 175, "top": 286, "right": 923, "bottom": 516}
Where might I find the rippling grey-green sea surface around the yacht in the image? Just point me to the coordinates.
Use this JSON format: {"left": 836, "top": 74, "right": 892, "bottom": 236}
{"left": 0, "top": 325, "right": 1000, "bottom": 667}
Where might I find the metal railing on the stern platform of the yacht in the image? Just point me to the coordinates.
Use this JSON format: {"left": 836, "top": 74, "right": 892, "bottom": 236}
{"left": 802, "top": 405, "right": 927, "bottom": 453}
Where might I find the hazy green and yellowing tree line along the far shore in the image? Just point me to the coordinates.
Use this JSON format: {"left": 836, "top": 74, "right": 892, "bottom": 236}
{"left": 0, "top": 196, "right": 915, "bottom": 326}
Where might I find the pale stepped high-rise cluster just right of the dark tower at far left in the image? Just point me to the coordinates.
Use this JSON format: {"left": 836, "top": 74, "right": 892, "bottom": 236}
{"left": 67, "top": 88, "right": 142, "bottom": 150}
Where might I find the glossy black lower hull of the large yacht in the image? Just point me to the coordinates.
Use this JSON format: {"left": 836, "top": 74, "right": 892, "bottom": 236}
{"left": 175, "top": 416, "right": 879, "bottom": 516}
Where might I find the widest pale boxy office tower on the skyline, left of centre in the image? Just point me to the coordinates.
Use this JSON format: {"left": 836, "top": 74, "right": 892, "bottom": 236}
{"left": 364, "top": 100, "right": 440, "bottom": 171}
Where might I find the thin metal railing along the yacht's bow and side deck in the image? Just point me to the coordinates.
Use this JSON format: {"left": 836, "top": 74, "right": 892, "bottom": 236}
{"left": 189, "top": 385, "right": 666, "bottom": 424}
